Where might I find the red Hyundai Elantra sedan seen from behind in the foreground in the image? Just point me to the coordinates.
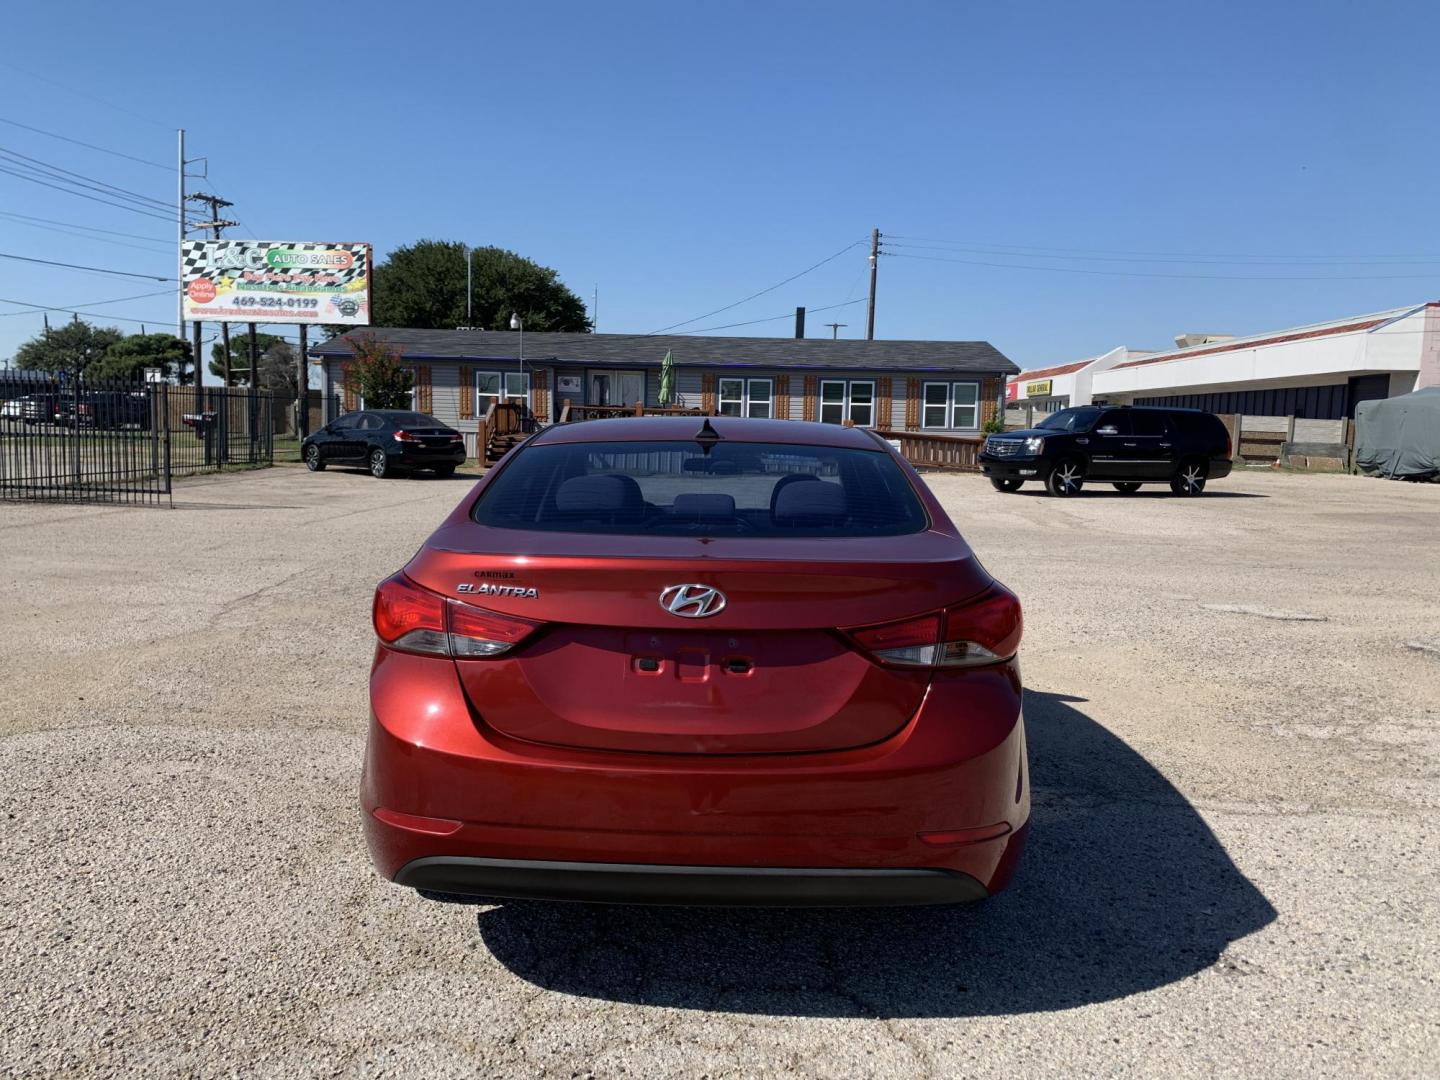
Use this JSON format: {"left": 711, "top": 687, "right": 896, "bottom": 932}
{"left": 361, "top": 418, "right": 1030, "bottom": 906}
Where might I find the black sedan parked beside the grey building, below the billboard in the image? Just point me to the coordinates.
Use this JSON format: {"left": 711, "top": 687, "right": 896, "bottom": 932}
{"left": 300, "top": 409, "right": 465, "bottom": 477}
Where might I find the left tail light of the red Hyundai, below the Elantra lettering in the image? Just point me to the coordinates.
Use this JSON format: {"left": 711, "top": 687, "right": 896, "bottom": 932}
{"left": 373, "top": 573, "right": 540, "bottom": 660}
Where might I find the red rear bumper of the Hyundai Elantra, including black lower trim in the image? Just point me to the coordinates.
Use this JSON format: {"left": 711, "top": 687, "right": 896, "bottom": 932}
{"left": 360, "top": 648, "right": 1030, "bottom": 904}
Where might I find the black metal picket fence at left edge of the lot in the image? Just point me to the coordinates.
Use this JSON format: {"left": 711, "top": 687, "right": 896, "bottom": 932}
{"left": 0, "top": 377, "right": 275, "bottom": 504}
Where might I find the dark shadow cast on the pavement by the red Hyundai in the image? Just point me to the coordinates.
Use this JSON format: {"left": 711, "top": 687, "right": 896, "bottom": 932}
{"left": 478, "top": 691, "right": 1276, "bottom": 1018}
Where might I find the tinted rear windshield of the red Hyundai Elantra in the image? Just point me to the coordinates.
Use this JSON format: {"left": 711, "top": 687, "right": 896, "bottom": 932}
{"left": 475, "top": 441, "right": 929, "bottom": 537}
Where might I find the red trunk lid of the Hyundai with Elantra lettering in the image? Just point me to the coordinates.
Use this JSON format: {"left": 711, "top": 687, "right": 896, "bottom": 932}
{"left": 406, "top": 524, "right": 989, "bottom": 753}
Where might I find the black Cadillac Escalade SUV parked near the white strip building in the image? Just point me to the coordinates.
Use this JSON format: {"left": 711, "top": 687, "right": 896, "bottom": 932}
{"left": 981, "top": 405, "right": 1231, "bottom": 495}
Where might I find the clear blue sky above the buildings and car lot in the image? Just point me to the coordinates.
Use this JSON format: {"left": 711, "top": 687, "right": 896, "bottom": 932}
{"left": 0, "top": 1, "right": 1440, "bottom": 377}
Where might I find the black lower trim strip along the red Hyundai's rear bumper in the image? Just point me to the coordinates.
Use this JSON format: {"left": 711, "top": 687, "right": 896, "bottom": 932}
{"left": 395, "top": 855, "right": 986, "bottom": 907}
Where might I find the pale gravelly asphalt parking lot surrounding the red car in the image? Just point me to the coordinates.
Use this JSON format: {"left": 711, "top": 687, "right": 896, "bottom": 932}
{"left": 0, "top": 468, "right": 1440, "bottom": 1077}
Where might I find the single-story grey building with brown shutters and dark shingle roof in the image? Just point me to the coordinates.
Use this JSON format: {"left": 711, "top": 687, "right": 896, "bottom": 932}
{"left": 310, "top": 334, "right": 1018, "bottom": 454}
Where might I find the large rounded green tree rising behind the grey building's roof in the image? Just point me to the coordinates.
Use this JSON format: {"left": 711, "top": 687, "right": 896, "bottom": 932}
{"left": 365, "top": 240, "right": 590, "bottom": 334}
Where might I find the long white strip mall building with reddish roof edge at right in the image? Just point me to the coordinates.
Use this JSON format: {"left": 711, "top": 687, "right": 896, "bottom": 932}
{"left": 1007, "top": 302, "right": 1440, "bottom": 420}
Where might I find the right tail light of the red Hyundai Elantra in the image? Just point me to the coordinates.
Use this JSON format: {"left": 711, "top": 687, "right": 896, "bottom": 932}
{"left": 847, "top": 585, "right": 1024, "bottom": 668}
